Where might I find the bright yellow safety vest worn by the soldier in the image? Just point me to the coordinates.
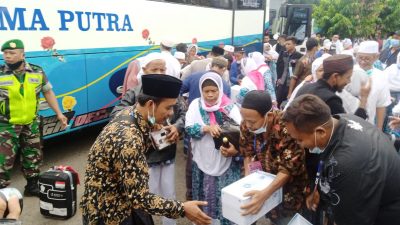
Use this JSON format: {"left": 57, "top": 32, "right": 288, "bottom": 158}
{"left": 0, "top": 72, "right": 43, "bottom": 125}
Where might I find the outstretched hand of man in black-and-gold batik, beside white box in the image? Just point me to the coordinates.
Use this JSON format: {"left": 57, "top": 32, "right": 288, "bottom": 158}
{"left": 183, "top": 201, "right": 212, "bottom": 225}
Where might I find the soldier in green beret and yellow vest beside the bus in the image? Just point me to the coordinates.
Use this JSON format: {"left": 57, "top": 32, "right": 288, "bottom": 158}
{"left": 0, "top": 39, "right": 67, "bottom": 196}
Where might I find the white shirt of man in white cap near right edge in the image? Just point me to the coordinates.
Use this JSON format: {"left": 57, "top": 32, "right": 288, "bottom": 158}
{"left": 356, "top": 65, "right": 391, "bottom": 124}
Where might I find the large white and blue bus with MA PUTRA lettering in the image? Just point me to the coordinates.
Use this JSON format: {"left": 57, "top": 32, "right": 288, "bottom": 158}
{"left": 0, "top": 0, "right": 269, "bottom": 139}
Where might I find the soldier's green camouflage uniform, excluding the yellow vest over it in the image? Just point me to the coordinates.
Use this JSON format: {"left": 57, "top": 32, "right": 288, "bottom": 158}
{"left": 0, "top": 62, "right": 52, "bottom": 188}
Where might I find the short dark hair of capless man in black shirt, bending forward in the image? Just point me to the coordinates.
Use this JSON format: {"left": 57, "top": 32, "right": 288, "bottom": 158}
{"left": 282, "top": 94, "right": 331, "bottom": 133}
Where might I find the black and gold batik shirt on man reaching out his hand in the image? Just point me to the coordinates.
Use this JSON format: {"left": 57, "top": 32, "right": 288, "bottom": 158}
{"left": 81, "top": 106, "right": 184, "bottom": 224}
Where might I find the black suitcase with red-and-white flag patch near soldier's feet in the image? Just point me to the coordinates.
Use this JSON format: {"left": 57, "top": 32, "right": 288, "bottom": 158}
{"left": 39, "top": 166, "right": 79, "bottom": 219}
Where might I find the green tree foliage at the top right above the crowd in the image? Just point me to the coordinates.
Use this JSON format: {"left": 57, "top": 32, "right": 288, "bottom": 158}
{"left": 313, "top": 0, "right": 400, "bottom": 37}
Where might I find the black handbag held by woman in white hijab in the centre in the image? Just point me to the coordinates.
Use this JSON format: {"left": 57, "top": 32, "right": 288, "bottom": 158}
{"left": 213, "top": 114, "right": 240, "bottom": 151}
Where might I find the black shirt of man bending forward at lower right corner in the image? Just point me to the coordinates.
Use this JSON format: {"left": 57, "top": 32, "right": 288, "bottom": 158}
{"left": 318, "top": 114, "right": 400, "bottom": 225}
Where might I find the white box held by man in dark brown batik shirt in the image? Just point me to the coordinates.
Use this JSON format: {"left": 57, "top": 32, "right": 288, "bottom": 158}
{"left": 221, "top": 171, "right": 282, "bottom": 225}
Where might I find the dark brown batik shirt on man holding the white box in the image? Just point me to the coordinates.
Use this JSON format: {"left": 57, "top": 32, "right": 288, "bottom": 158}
{"left": 240, "top": 111, "right": 308, "bottom": 219}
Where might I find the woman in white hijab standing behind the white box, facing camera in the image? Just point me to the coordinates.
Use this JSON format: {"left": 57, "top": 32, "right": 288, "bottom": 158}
{"left": 185, "top": 72, "right": 241, "bottom": 224}
